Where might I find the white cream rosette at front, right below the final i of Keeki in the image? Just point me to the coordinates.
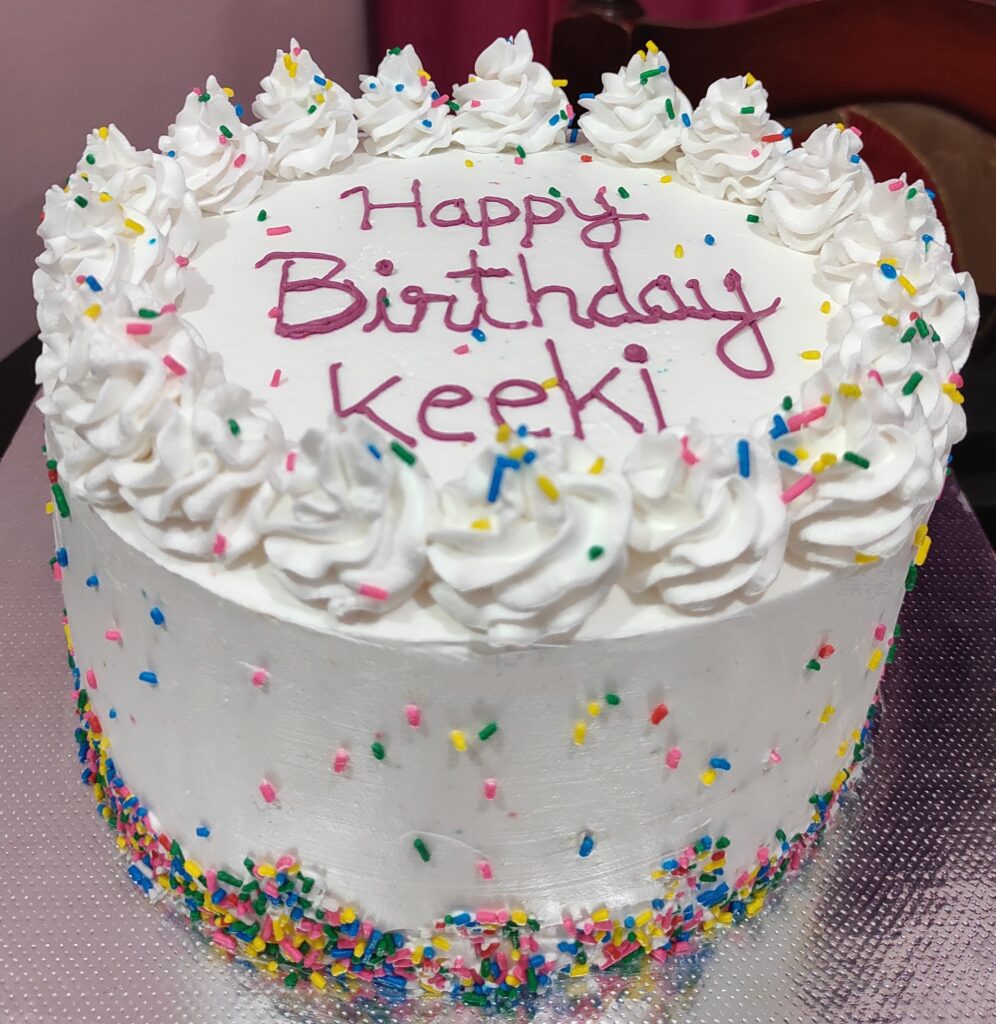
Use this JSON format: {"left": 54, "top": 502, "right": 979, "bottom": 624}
{"left": 623, "top": 424, "right": 787, "bottom": 612}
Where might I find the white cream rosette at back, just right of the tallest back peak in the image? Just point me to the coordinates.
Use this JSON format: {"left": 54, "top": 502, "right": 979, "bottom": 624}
{"left": 578, "top": 43, "right": 692, "bottom": 164}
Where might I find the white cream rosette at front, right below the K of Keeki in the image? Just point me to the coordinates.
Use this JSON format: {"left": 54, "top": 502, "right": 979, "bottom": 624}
{"left": 263, "top": 417, "right": 431, "bottom": 617}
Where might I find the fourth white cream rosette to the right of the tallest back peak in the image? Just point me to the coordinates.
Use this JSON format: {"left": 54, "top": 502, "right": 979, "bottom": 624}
{"left": 816, "top": 174, "right": 947, "bottom": 302}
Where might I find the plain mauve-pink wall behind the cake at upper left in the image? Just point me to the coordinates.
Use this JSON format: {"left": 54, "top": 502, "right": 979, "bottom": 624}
{"left": 0, "top": 0, "right": 367, "bottom": 358}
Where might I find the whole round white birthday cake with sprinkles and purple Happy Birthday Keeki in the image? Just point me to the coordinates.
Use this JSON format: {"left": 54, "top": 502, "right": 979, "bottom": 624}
{"left": 35, "top": 33, "right": 978, "bottom": 1005}
